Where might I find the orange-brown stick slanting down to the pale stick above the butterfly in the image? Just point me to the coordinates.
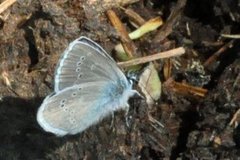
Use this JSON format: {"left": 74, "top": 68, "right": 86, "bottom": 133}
{"left": 107, "top": 10, "right": 137, "bottom": 58}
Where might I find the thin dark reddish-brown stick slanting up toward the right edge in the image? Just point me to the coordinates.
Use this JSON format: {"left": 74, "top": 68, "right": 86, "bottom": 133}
{"left": 203, "top": 40, "right": 234, "bottom": 67}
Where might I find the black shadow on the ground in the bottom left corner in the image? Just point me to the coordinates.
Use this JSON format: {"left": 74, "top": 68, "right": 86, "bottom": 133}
{"left": 0, "top": 97, "right": 67, "bottom": 160}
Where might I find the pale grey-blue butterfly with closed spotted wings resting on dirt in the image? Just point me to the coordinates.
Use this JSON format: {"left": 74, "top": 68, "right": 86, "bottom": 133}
{"left": 37, "top": 36, "right": 139, "bottom": 136}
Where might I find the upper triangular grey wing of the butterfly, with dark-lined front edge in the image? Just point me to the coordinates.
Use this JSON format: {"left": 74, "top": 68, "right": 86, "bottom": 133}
{"left": 54, "top": 37, "right": 127, "bottom": 92}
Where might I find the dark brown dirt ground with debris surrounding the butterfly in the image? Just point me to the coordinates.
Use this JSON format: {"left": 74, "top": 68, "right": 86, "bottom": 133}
{"left": 0, "top": 0, "right": 240, "bottom": 160}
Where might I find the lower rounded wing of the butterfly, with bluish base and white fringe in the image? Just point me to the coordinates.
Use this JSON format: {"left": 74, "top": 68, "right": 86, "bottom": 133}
{"left": 37, "top": 82, "right": 118, "bottom": 136}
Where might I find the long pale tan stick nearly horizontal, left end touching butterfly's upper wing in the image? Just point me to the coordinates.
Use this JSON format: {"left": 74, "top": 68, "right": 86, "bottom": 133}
{"left": 117, "top": 47, "right": 185, "bottom": 67}
